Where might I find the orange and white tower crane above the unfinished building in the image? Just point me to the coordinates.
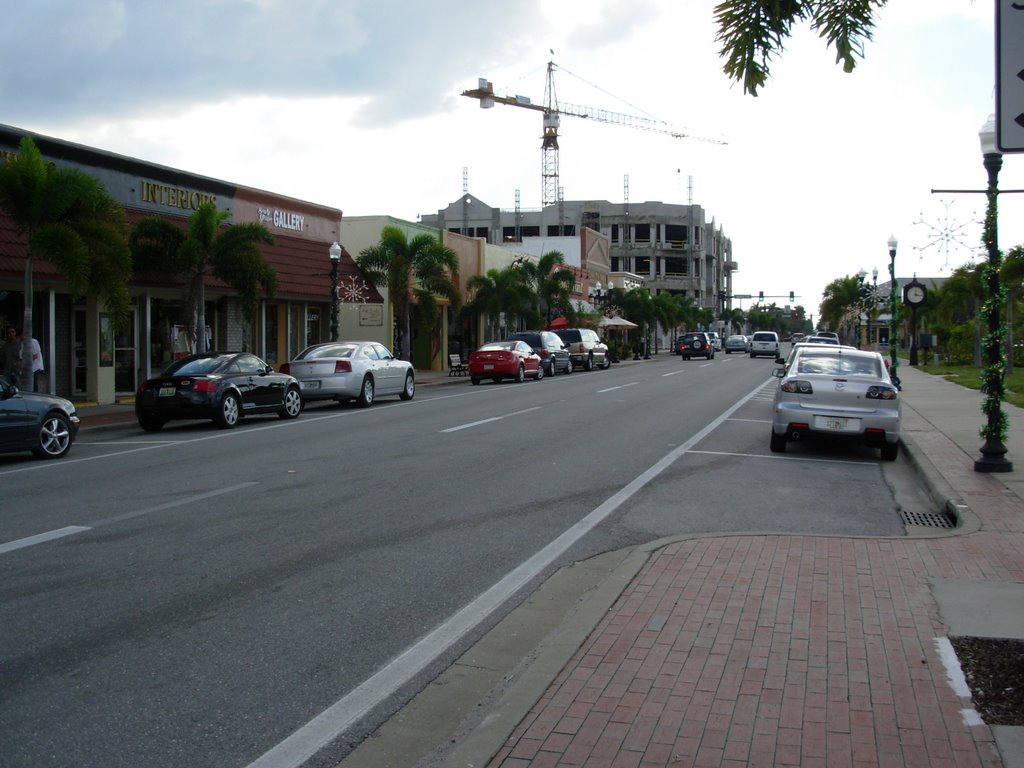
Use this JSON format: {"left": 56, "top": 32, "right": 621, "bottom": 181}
{"left": 462, "top": 61, "right": 726, "bottom": 206}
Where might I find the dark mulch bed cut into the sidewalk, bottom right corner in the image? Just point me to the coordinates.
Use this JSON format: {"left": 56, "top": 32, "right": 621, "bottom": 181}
{"left": 949, "top": 637, "right": 1024, "bottom": 725}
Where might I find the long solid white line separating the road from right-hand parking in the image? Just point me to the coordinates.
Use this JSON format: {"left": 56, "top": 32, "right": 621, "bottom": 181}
{"left": 248, "top": 382, "right": 757, "bottom": 768}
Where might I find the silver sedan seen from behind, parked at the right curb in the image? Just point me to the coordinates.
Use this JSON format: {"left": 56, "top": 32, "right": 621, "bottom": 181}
{"left": 771, "top": 345, "right": 900, "bottom": 461}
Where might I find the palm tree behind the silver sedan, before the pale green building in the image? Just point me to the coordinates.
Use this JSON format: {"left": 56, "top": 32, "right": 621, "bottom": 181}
{"left": 355, "top": 224, "right": 460, "bottom": 360}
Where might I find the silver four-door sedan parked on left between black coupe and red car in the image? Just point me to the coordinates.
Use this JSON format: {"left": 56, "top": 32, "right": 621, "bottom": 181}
{"left": 281, "top": 341, "right": 416, "bottom": 408}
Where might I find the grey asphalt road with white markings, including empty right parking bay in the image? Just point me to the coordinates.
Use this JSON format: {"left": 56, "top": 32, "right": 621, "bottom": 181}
{"left": 0, "top": 354, "right": 903, "bottom": 768}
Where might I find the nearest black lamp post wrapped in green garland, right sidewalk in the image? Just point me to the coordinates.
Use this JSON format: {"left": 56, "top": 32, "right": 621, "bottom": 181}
{"left": 974, "top": 115, "right": 1014, "bottom": 472}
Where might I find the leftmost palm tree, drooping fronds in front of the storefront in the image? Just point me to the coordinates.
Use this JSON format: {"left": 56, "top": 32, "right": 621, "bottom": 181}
{"left": 0, "top": 136, "right": 131, "bottom": 381}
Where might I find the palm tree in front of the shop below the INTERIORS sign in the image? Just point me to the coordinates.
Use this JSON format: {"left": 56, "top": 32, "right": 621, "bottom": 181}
{"left": 131, "top": 202, "right": 278, "bottom": 352}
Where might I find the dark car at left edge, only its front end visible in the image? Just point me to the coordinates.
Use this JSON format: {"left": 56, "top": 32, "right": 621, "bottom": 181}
{"left": 0, "top": 380, "right": 78, "bottom": 459}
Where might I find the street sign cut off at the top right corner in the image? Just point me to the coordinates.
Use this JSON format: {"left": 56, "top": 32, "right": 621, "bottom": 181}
{"left": 995, "top": 0, "right": 1024, "bottom": 153}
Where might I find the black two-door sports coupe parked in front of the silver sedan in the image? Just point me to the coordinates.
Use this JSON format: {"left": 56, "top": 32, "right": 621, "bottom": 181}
{"left": 135, "top": 352, "right": 302, "bottom": 432}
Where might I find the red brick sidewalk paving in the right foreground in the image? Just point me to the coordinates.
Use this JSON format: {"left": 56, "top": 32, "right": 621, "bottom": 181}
{"left": 489, "top": 410, "right": 1024, "bottom": 768}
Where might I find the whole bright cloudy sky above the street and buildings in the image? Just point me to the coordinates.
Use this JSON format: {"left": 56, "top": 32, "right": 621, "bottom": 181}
{"left": 0, "top": 0, "right": 1024, "bottom": 315}
